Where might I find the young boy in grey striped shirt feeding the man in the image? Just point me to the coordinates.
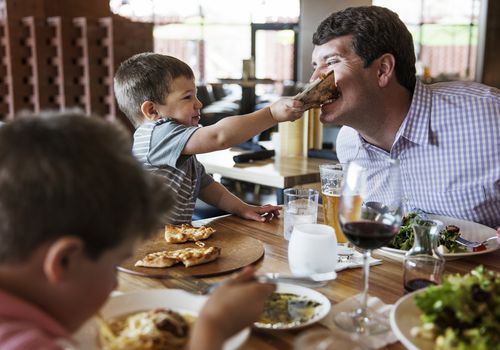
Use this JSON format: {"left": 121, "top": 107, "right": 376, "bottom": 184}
{"left": 114, "top": 53, "right": 305, "bottom": 224}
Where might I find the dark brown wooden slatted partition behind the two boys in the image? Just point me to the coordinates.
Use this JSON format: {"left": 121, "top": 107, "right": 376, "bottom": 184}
{"left": 0, "top": 0, "right": 153, "bottom": 131}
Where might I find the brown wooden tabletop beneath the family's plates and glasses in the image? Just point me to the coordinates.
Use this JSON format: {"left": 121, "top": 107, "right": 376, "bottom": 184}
{"left": 118, "top": 210, "right": 500, "bottom": 350}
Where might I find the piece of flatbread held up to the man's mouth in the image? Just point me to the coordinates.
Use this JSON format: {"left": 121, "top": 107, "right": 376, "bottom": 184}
{"left": 293, "top": 70, "right": 339, "bottom": 107}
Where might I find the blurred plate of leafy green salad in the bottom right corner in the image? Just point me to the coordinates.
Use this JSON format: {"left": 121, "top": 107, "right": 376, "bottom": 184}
{"left": 390, "top": 266, "right": 500, "bottom": 350}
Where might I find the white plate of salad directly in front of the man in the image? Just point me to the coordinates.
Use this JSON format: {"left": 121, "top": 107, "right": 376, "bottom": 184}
{"left": 381, "top": 213, "right": 500, "bottom": 260}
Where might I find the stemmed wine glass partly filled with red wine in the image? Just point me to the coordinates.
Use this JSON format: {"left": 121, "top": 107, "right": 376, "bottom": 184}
{"left": 335, "top": 159, "right": 403, "bottom": 334}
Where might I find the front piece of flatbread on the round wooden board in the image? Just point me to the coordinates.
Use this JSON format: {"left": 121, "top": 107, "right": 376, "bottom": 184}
{"left": 135, "top": 247, "right": 221, "bottom": 268}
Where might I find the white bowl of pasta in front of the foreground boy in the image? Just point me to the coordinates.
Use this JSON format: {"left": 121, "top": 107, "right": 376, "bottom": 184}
{"left": 73, "top": 289, "right": 250, "bottom": 350}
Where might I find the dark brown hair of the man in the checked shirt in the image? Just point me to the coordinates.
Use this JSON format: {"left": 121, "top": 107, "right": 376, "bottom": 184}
{"left": 313, "top": 6, "right": 416, "bottom": 93}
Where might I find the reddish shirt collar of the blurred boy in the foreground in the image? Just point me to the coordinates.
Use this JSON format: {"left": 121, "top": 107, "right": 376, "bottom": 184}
{"left": 0, "top": 290, "right": 70, "bottom": 338}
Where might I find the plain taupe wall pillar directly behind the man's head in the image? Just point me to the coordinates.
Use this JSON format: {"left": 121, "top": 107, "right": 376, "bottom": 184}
{"left": 297, "top": 0, "right": 372, "bottom": 82}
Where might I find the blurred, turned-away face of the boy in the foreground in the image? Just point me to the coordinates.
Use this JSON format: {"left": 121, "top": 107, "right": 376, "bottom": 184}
{"left": 59, "top": 239, "right": 136, "bottom": 331}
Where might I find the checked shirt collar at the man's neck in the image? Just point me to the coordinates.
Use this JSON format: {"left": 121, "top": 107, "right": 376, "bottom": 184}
{"left": 396, "top": 79, "right": 432, "bottom": 145}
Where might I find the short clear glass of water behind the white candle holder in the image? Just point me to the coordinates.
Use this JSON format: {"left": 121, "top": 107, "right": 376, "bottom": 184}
{"left": 283, "top": 188, "right": 319, "bottom": 240}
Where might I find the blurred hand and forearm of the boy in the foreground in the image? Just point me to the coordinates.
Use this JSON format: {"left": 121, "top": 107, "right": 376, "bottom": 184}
{"left": 188, "top": 267, "right": 276, "bottom": 350}
